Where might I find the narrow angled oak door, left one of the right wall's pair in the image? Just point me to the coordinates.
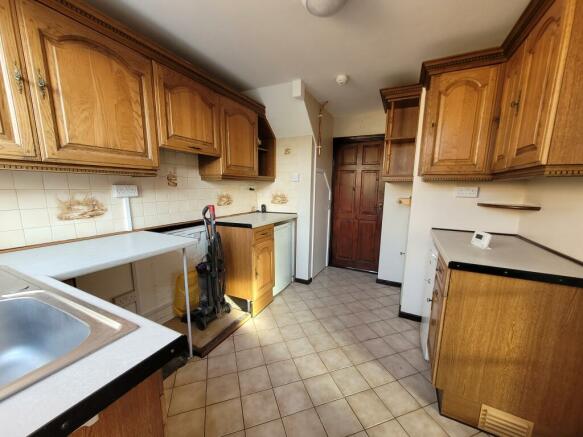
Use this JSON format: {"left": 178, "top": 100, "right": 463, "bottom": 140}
{"left": 492, "top": 45, "right": 524, "bottom": 171}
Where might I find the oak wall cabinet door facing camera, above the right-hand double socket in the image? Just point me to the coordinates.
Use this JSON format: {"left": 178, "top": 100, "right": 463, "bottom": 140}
{"left": 422, "top": 65, "right": 499, "bottom": 175}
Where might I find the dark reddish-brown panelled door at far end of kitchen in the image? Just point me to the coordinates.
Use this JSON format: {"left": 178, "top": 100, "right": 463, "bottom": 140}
{"left": 331, "top": 141, "right": 384, "bottom": 272}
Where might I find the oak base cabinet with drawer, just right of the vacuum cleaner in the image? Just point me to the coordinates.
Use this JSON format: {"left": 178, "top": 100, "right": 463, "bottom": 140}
{"left": 218, "top": 225, "right": 275, "bottom": 316}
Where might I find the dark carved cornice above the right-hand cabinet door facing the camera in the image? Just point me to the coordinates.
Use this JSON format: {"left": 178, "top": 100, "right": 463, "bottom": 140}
{"left": 419, "top": 47, "right": 507, "bottom": 88}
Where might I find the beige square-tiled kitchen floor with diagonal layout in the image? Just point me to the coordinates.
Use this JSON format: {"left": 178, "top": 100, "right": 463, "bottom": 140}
{"left": 164, "top": 268, "right": 485, "bottom": 437}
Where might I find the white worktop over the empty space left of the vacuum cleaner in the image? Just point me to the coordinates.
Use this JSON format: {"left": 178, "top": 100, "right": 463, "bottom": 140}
{"left": 0, "top": 231, "right": 196, "bottom": 280}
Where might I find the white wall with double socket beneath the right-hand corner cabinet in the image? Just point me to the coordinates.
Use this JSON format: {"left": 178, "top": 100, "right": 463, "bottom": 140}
{"left": 401, "top": 91, "right": 525, "bottom": 315}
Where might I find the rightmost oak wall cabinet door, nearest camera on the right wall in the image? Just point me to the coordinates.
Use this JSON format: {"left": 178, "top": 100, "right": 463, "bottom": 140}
{"left": 509, "top": 0, "right": 564, "bottom": 167}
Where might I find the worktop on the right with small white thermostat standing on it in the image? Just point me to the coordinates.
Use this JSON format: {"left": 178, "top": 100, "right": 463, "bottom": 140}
{"left": 432, "top": 229, "right": 583, "bottom": 278}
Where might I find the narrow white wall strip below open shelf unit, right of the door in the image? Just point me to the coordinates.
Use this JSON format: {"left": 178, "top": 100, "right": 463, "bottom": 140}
{"left": 378, "top": 182, "right": 413, "bottom": 283}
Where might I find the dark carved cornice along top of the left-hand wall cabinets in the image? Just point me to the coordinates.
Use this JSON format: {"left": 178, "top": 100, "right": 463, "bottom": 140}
{"left": 38, "top": 0, "right": 265, "bottom": 115}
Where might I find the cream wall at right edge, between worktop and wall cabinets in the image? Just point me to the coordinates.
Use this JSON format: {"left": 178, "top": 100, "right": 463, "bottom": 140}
{"left": 519, "top": 178, "right": 583, "bottom": 261}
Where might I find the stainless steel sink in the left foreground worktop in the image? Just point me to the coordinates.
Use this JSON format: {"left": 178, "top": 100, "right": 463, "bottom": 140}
{"left": 0, "top": 268, "right": 137, "bottom": 400}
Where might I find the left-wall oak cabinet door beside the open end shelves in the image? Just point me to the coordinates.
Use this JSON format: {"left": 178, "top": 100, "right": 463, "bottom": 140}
{"left": 220, "top": 97, "right": 258, "bottom": 177}
